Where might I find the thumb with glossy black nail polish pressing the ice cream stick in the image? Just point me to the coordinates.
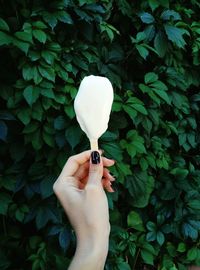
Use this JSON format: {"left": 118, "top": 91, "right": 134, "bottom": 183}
{"left": 87, "top": 151, "right": 103, "bottom": 185}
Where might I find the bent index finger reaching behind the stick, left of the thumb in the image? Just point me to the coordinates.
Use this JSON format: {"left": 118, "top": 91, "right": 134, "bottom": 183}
{"left": 61, "top": 150, "right": 102, "bottom": 177}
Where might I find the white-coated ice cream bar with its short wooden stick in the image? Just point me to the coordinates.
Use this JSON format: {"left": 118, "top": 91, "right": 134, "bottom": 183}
{"left": 74, "top": 75, "right": 113, "bottom": 150}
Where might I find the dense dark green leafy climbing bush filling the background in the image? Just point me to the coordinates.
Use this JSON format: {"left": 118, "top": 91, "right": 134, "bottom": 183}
{"left": 0, "top": 0, "right": 200, "bottom": 270}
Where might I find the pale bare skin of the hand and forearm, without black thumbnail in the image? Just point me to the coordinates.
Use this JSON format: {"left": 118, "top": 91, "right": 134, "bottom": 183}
{"left": 53, "top": 151, "right": 114, "bottom": 270}
